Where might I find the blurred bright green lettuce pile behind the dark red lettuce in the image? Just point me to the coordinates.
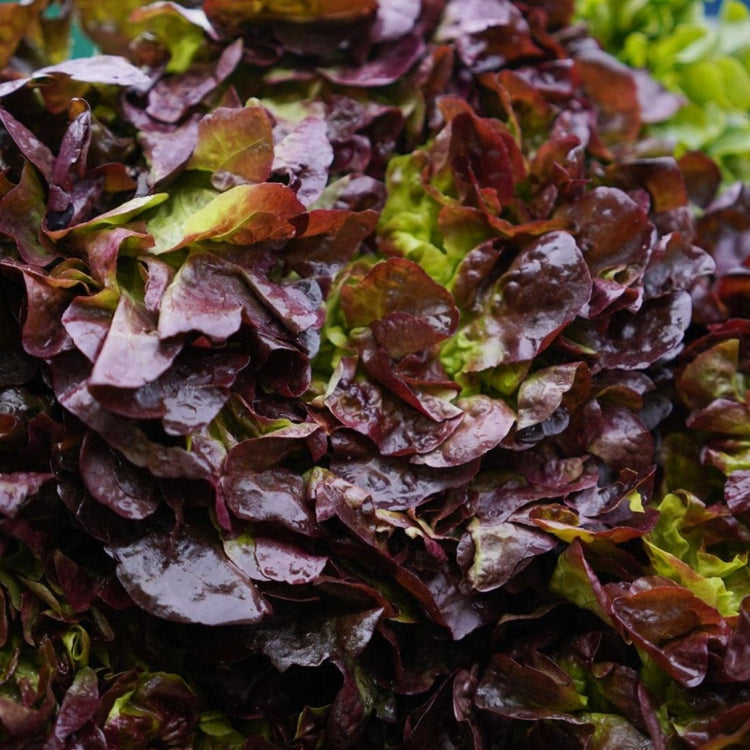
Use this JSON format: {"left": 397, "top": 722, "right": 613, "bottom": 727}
{"left": 576, "top": 0, "right": 750, "bottom": 182}
